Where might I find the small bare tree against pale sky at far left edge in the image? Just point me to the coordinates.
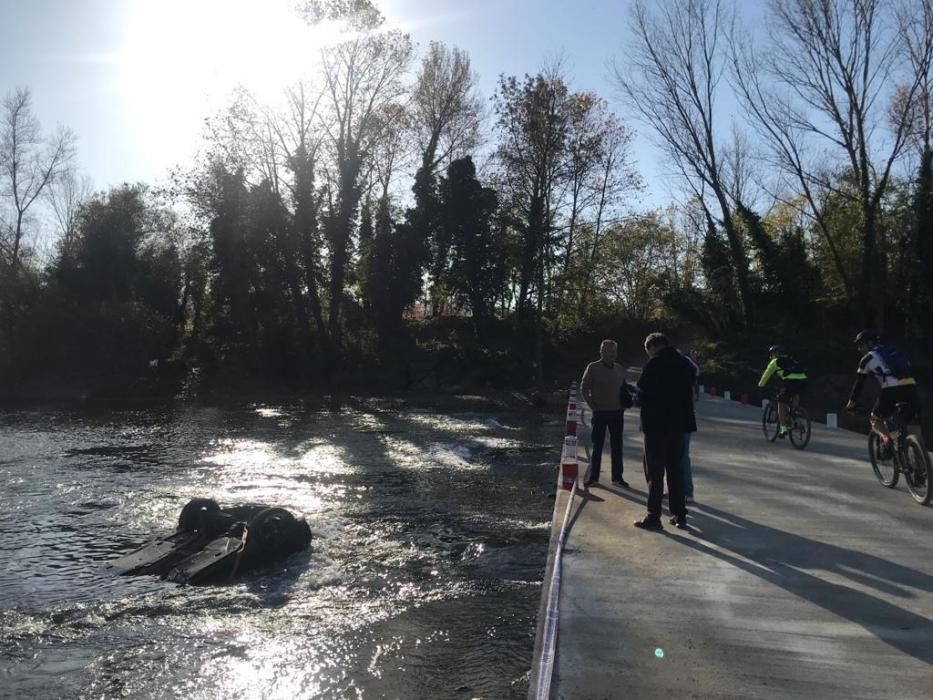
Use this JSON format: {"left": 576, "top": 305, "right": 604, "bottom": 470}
{"left": 0, "top": 88, "right": 74, "bottom": 278}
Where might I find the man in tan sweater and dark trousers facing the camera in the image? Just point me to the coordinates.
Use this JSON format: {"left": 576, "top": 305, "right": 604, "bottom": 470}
{"left": 580, "top": 340, "right": 628, "bottom": 487}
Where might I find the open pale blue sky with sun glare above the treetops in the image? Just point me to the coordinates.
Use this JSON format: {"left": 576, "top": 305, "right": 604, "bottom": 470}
{"left": 0, "top": 0, "right": 759, "bottom": 206}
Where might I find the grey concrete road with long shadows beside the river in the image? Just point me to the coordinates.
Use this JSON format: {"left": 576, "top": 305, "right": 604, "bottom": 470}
{"left": 551, "top": 398, "right": 933, "bottom": 700}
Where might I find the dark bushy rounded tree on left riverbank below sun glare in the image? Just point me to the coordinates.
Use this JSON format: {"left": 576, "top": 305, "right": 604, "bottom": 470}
{"left": 38, "top": 185, "right": 182, "bottom": 376}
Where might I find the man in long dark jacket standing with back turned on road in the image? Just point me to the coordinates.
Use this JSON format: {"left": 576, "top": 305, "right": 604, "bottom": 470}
{"left": 635, "top": 333, "right": 697, "bottom": 530}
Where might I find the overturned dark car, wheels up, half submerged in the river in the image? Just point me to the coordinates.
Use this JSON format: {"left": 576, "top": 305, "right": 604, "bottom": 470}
{"left": 107, "top": 498, "right": 311, "bottom": 583}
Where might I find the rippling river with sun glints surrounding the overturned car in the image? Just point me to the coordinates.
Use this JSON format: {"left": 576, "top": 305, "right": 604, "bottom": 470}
{"left": 0, "top": 396, "right": 563, "bottom": 700}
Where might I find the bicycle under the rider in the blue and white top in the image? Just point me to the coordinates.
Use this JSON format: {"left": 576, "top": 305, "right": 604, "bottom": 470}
{"left": 868, "top": 403, "right": 933, "bottom": 506}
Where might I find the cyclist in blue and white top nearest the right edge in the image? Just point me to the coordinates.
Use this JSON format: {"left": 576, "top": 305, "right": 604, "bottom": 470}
{"left": 846, "top": 330, "right": 924, "bottom": 445}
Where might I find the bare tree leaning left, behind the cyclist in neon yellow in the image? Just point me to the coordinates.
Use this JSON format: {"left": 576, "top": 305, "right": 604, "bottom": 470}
{"left": 614, "top": 0, "right": 749, "bottom": 319}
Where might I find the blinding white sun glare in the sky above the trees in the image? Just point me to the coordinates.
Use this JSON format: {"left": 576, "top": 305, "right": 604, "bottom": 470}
{"left": 116, "top": 0, "right": 339, "bottom": 175}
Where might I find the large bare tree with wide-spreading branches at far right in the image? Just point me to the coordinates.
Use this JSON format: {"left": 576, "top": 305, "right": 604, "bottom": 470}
{"left": 732, "top": 0, "right": 930, "bottom": 326}
